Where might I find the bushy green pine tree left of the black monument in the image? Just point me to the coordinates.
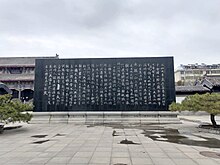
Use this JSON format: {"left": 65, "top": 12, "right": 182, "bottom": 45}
{"left": 0, "top": 94, "right": 33, "bottom": 123}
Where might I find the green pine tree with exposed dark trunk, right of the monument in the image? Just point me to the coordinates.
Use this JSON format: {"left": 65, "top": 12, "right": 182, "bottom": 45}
{"left": 169, "top": 93, "right": 220, "bottom": 128}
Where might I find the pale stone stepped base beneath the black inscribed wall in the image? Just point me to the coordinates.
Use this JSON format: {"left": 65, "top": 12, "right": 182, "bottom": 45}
{"left": 31, "top": 111, "right": 181, "bottom": 124}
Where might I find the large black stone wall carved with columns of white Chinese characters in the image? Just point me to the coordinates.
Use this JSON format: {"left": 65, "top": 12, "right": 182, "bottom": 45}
{"left": 34, "top": 57, "right": 175, "bottom": 112}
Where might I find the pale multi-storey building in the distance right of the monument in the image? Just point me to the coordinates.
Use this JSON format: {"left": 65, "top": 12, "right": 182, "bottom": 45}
{"left": 175, "top": 63, "right": 220, "bottom": 85}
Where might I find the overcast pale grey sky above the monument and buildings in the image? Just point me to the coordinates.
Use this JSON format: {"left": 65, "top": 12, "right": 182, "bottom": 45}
{"left": 0, "top": 0, "right": 220, "bottom": 67}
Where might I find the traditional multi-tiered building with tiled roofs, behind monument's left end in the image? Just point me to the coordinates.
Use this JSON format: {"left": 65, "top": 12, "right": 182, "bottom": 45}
{"left": 0, "top": 55, "right": 58, "bottom": 101}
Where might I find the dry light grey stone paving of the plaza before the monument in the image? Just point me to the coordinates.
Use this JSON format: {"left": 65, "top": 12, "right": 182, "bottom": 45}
{"left": 0, "top": 116, "right": 220, "bottom": 165}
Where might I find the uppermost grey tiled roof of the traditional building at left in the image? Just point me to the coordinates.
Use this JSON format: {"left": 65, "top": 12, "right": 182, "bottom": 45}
{"left": 0, "top": 56, "right": 57, "bottom": 66}
